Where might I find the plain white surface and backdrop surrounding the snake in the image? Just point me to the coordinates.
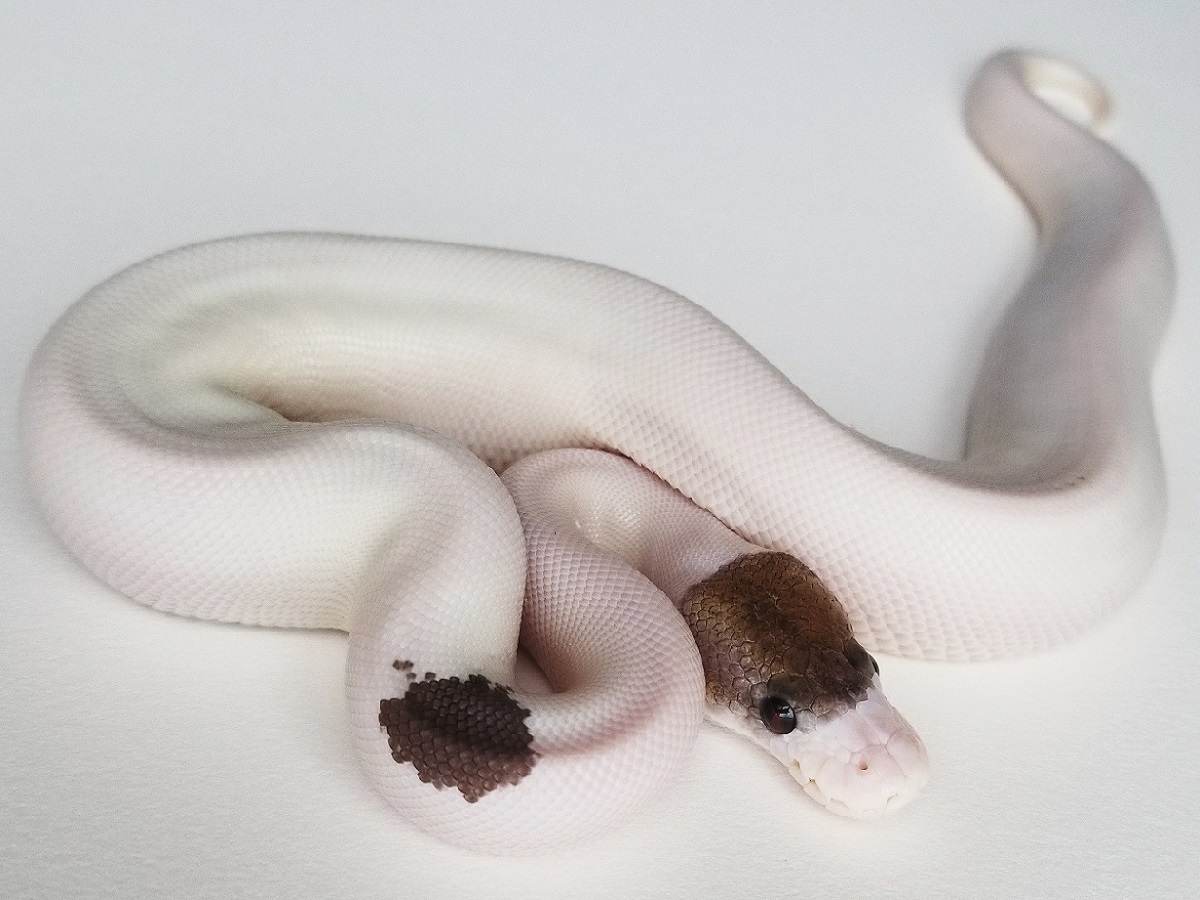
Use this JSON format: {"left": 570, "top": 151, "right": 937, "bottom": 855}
{"left": 0, "top": 0, "right": 1200, "bottom": 900}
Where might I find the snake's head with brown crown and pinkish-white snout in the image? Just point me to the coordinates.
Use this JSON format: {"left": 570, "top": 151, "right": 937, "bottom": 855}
{"left": 682, "top": 553, "right": 929, "bottom": 818}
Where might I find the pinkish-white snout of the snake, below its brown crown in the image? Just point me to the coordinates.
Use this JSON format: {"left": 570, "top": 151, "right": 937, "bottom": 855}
{"left": 773, "top": 678, "right": 929, "bottom": 818}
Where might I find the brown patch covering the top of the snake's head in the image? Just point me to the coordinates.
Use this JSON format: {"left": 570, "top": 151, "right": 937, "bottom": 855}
{"left": 680, "top": 553, "right": 876, "bottom": 715}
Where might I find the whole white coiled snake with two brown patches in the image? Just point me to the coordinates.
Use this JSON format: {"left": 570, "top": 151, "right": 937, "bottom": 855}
{"left": 22, "top": 53, "right": 1172, "bottom": 852}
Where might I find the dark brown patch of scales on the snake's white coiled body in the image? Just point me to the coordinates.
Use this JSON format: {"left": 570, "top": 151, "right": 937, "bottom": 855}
{"left": 379, "top": 672, "right": 538, "bottom": 803}
